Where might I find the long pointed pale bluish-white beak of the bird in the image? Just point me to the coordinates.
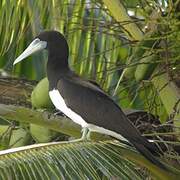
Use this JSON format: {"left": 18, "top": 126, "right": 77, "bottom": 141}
{"left": 13, "top": 38, "right": 47, "bottom": 66}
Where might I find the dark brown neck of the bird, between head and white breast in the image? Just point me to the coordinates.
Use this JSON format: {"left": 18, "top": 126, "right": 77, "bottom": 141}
{"left": 47, "top": 54, "right": 71, "bottom": 89}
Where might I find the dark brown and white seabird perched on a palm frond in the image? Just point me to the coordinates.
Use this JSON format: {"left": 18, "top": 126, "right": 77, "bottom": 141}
{"left": 13, "top": 30, "right": 166, "bottom": 169}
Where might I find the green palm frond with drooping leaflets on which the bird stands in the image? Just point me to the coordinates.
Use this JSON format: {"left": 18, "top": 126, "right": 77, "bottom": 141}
{"left": 0, "top": 140, "right": 178, "bottom": 180}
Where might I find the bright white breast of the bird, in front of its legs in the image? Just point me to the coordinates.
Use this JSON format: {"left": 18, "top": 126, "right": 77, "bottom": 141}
{"left": 49, "top": 89, "right": 87, "bottom": 127}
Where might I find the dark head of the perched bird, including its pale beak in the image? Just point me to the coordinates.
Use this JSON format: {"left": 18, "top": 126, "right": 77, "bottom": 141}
{"left": 13, "top": 31, "right": 68, "bottom": 65}
